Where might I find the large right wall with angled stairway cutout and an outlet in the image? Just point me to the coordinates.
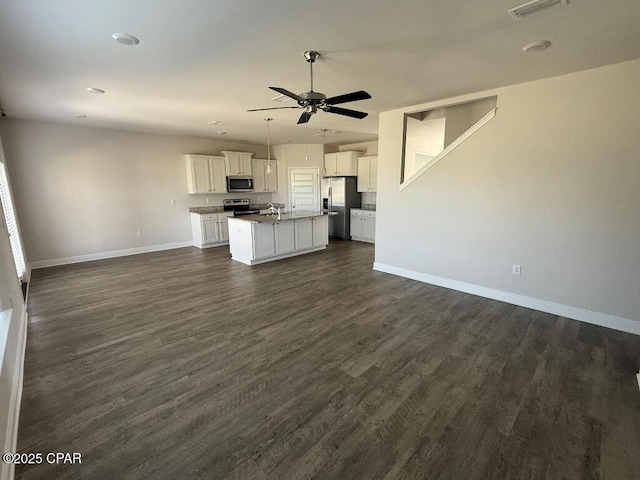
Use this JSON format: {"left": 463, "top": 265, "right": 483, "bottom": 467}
{"left": 376, "top": 60, "right": 640, "bottom": 333}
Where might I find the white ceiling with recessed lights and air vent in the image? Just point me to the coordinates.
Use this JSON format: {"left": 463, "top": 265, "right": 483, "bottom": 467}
{"left": 0, "top": 0, "right": 640, "bottom": 144}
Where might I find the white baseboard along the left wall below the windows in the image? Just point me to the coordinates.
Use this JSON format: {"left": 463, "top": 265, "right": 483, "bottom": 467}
{"left": 0, "top": 308, "right": 28, "bottom": 480}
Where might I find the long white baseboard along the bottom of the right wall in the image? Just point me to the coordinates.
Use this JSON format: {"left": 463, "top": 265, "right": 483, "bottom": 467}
{"left": 373, "top": 262, "right": 640, "bottom": 335}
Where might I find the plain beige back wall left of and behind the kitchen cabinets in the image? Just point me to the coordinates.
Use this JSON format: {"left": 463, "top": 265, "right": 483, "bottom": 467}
{"left": 0, "top": 120, "right": 271, "bottom": 262}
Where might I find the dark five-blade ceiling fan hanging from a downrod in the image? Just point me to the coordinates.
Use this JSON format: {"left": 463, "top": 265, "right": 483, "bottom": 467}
{"left": 247, "top": 50, "right": 371, "bottom": 124}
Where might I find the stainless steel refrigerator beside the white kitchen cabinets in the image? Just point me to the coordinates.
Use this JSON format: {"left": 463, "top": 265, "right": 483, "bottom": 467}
{"left": 322, "top": 177, "right": 362, "bottom": 240}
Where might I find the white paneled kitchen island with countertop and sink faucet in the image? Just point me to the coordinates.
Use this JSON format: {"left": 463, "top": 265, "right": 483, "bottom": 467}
{"left": 229, "top": 211, "right": 330, "bottom": 265}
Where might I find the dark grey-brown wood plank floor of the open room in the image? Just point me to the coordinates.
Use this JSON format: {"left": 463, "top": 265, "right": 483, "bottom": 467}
{"left": 16, "top": 242, "right": 640, "bottom": 480}
